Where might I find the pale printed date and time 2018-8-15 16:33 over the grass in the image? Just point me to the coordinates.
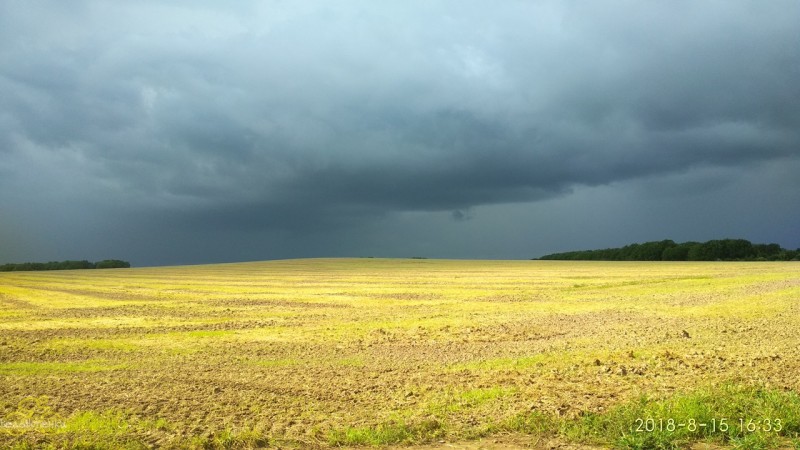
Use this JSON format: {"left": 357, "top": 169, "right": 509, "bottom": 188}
{"left": 631, "top": 417, "right": 783, "bottom": 433}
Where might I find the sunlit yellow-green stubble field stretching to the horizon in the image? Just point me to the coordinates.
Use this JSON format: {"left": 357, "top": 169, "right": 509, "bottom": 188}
{"left": 0, "top": 258, "right": 800, "bottom": 448}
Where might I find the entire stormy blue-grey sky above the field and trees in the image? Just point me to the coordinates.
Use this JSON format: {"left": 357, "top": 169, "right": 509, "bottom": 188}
{"left": 0, "top": 0, "right": 800, "bottom": 265}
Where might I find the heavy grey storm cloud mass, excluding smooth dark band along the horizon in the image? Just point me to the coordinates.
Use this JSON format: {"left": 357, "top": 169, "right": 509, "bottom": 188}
{"left": 0, "top": 1, "right": 800, "bottom": 237}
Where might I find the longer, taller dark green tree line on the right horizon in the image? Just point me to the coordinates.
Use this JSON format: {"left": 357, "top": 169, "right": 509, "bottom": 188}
{"left": 534, "top": 239, "right": 800, "bottom": 261}
